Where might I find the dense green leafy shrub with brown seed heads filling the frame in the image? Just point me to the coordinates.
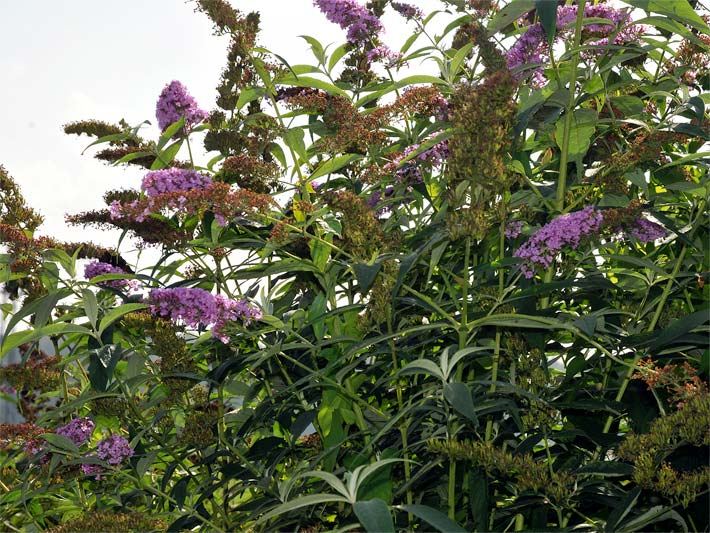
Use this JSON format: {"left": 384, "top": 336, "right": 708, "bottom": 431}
{"left": 0, "top": 0, "right": 710, "bottom": 532}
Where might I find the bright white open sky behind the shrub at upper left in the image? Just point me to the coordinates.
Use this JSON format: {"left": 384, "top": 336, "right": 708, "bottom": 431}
{"left": 0, "top": 0, "right": 438, "bottom": 254}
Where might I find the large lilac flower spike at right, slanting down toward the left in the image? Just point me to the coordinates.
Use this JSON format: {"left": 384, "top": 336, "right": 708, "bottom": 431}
{"left": 513, "top": 206, "right": 604, "bottom": 279}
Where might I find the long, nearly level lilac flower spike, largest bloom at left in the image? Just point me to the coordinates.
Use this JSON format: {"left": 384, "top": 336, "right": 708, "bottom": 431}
{"left": 148, "top": 287, "right": 262, "bottom": 344}
